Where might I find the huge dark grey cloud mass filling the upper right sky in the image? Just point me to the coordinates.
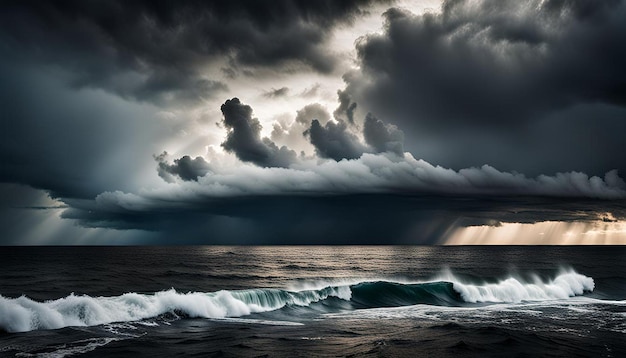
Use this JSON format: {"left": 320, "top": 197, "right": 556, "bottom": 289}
{"left": 338, "top": 0, "right": 626, "bottom": 174}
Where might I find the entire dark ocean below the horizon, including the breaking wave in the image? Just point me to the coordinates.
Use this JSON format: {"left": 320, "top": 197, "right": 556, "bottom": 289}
{"left": 0, "top": 246, "right": 626, "bottom": 357}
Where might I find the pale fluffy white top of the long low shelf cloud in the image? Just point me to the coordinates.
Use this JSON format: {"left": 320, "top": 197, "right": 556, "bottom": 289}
{"left": 147, "top": 153, "right": 626, "bottom": 201}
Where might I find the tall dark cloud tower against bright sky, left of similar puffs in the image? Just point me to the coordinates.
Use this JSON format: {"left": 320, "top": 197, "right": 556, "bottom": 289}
{"left": 221, "top": 98, "right": 296, "bottom": 167}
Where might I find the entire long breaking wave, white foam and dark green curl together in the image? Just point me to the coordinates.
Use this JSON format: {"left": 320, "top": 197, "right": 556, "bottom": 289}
{"left": 0, "top": 271, "right": 594, "bottom": 332}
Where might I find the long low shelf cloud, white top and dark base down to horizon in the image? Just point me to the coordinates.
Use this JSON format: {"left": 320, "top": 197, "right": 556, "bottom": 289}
{"left": 53, "top": 154, "right": 626, "bottom": 244}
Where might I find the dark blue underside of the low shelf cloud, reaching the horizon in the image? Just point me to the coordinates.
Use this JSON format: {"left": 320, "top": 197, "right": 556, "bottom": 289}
{"left": 64, "top": 195, "right": 452, "bottom": 244}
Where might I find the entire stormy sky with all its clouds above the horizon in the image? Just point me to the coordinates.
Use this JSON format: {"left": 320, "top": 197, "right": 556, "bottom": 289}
{"left": 0, "top": 0, "right": 626, "bottom": 245}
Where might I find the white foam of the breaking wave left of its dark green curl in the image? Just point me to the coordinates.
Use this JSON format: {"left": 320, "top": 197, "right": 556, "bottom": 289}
{"left": 0, "top": 287, "right": 350, "bottom": 332}
